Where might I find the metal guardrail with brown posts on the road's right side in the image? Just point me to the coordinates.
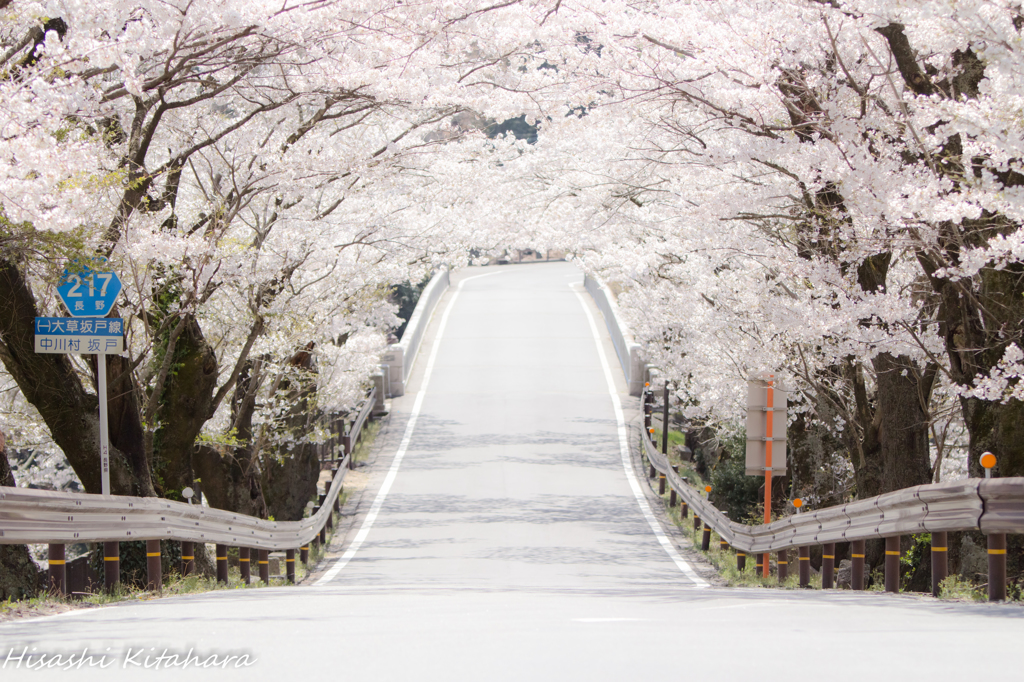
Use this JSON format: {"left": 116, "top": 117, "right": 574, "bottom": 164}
{"left": 640, "top": 391, "right": 1024, "bottom": 600}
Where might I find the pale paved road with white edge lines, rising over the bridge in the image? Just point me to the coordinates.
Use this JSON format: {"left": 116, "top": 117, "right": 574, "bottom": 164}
{"left": 0, "top": 264, "right": 1024, "bottom": 682}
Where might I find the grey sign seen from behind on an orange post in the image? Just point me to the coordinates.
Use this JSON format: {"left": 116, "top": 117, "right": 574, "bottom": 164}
{"left": 745, "top": 374, "right": 788, "bottom": 578}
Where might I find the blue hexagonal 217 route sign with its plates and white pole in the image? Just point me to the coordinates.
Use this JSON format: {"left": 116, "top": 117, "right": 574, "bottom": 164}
{"left": 36, "top": 261, "right": 125, "bottom": 495}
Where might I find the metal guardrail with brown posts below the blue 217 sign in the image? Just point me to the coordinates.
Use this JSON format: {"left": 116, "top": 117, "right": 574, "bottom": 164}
{"left": 0, "top": 390, "right": 376, "bottom": 594}
